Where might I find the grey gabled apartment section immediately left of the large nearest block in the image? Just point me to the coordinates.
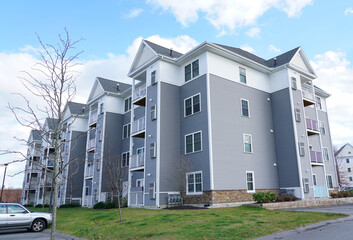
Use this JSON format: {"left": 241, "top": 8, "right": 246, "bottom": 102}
{"left": 82, "top": 77, "right": 131, "bottom": 207}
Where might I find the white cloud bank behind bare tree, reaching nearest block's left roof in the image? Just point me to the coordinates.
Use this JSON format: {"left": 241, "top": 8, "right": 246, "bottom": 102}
{"left": 0, "top": 35, "right": 198, "bottom": 187}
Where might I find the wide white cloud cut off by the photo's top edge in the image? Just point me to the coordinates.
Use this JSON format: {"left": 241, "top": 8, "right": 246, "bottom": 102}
{"left": 146, "top": 0, "right": 312, "bottom": 32}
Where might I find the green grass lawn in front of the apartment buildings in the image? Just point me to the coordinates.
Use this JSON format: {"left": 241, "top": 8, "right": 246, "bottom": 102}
{"left": 30, "top": 206, "right": 346, "bottom": 240}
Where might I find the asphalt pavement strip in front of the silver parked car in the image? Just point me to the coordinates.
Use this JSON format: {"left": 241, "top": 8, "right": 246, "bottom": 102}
{"left": 0, "top": 230, "right": 80, "bottom": 240}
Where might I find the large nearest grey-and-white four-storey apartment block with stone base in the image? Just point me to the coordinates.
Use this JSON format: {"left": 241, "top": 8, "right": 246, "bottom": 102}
{"left": 128, "top": 40, "right": 338, "bottom": 207}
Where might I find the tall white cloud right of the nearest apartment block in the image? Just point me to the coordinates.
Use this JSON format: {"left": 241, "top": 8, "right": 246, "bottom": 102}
{"left": 311, "top": 51, "right": 353, "bottom": 146}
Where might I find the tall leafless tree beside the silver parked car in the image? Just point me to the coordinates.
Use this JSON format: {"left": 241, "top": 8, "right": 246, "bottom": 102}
{"left": 3, "top": 29, "right": 82, "bottom": 239}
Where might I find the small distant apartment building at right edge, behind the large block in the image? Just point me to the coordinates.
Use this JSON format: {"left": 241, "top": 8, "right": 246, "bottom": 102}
{"left": 335, "top": 143, "right": 353, "bottom": 189}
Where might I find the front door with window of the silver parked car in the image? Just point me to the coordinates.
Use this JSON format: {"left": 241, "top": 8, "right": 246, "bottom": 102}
{"left": 7, "top": 205, "right": 31, "bottom": 228}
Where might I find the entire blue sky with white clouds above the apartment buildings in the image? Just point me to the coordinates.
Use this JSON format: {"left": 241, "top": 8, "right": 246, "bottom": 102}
{"left": 0, "top": 0, "right": 353, "bottom": 188}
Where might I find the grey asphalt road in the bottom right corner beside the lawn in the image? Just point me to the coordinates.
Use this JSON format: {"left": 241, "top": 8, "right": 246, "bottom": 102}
{"left": 257, "top": 204, "right": 353, "bottom": 240}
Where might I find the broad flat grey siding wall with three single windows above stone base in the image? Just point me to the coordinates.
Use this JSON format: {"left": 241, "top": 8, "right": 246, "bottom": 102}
{"left": 209, "top": 74, "right": 278, "bottom": 190}
